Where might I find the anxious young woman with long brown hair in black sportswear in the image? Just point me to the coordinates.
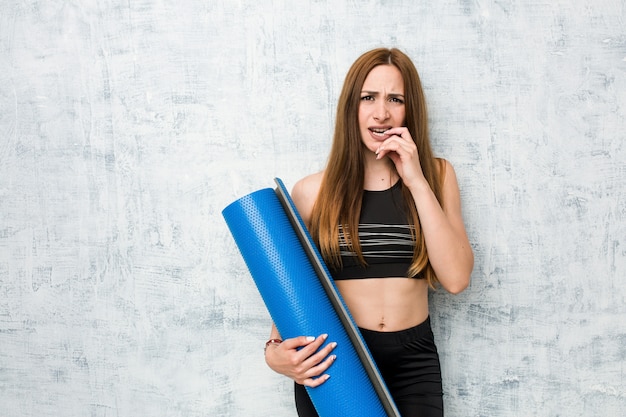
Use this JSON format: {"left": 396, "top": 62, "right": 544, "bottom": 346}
{"left": 265, "top": 49, "right": 474, "bottom": 417}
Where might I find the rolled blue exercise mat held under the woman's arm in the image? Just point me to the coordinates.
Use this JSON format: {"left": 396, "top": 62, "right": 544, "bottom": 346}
{"left": 222, "top": 178, "right": 400, "bottom": 417}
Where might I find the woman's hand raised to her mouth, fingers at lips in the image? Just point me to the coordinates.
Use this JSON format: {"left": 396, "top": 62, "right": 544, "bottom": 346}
{"left": 376, "top": 127, "right": 425, "bottom": 188}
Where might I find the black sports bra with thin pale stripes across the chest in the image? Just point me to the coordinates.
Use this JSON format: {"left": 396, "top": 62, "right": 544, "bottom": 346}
{"left": 330, "top": 181, "right": 421, "bottom": 280}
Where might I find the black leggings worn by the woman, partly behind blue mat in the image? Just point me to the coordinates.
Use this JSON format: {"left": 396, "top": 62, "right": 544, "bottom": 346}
{"left": 295, "top": 318, "right": 443, "bottom": 417}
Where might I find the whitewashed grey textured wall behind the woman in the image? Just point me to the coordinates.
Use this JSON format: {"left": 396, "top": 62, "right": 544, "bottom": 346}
{"left": 0, "top": 0, "right": 626, "bottom": 417}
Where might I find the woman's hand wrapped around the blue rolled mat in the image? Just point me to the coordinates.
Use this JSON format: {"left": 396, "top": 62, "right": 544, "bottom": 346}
{"left": 265, "top": 334, "right": 337, "bottom": 387}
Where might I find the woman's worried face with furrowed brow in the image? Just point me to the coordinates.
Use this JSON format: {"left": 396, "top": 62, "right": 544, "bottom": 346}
{"left": 359, "top": 65, "right": 406, "bottom": 152}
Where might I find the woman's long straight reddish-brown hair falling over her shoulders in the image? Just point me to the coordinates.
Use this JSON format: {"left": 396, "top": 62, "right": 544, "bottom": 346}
{"left": 310, "top": 48, "right": 445, "bottom": 287}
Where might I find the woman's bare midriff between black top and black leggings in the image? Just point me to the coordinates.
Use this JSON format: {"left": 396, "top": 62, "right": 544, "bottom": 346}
{"left": 335, "top": 278, "right": 428, "bottom": 332}
